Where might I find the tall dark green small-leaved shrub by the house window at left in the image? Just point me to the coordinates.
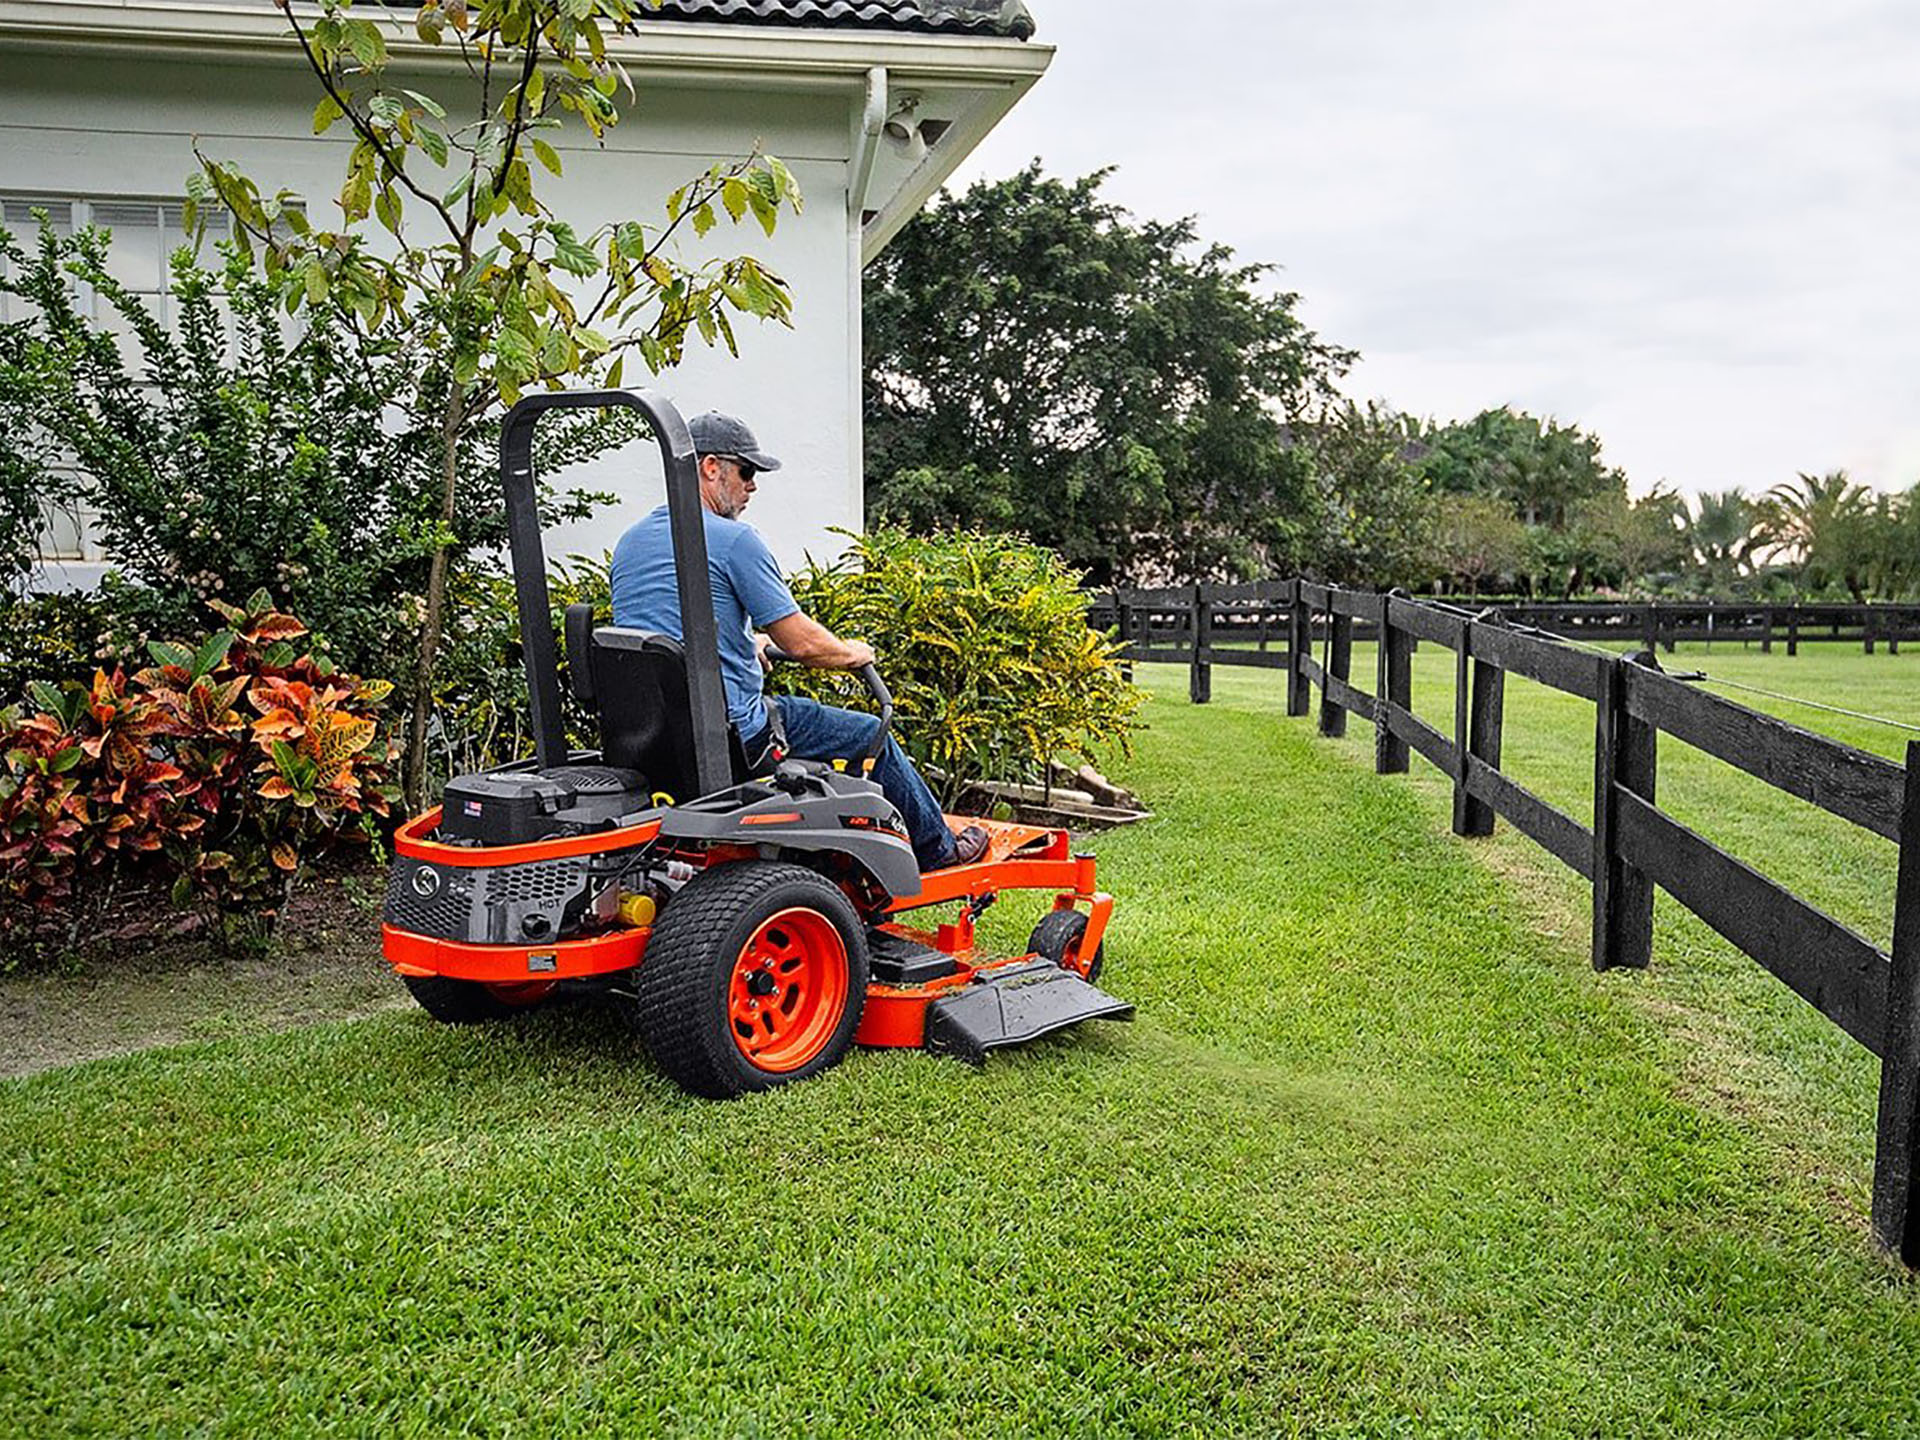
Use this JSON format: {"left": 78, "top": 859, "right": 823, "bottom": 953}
{"left": 0, "top": 227, "right": 639, "bottom": 718}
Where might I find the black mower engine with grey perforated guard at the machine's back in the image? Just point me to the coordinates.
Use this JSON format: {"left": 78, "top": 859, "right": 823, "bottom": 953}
{"left": 386, "top": 764, "right": 649, "bottom": 945}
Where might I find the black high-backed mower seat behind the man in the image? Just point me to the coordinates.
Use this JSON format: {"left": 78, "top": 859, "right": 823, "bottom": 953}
{"left": 566, "top": 605, "right": 753, "bottom": 814}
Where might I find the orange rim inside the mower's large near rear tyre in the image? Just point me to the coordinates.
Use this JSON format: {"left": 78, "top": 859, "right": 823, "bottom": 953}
{"left": 726, "top": 908, "right": 849, "bottom": 1075}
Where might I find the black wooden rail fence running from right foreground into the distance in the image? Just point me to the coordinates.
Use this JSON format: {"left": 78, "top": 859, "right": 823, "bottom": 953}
{"left": 1096, "top": 580, "right": 1920, "bottom": 1267}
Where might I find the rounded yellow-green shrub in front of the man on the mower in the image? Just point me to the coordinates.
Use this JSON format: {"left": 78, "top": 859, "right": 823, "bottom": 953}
{"left": 776, "top": 530, "right": 1142, "bottom": 803}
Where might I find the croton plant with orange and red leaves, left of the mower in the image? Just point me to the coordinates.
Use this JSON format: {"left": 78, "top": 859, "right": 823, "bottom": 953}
{"left": 0, "top": 591, "right": 399, "bottom": 940}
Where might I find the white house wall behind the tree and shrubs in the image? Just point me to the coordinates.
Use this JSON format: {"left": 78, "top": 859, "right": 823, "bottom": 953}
{"left": 0, "top": 52, "right": 860, "bottom": 566}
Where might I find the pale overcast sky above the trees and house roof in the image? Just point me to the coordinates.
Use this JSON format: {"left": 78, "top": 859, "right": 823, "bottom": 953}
{"left": 956, "top": 0, "right": 1920, "bottom": 493}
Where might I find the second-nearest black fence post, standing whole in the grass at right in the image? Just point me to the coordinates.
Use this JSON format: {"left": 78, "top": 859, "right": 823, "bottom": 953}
{"left": 1594, "top": 649, "right": 1661, "bottom": 970}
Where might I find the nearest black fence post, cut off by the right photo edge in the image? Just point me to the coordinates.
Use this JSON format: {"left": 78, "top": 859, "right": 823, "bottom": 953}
{"left": 1874, "top": 741, "right": 1920, "bottom": 1265}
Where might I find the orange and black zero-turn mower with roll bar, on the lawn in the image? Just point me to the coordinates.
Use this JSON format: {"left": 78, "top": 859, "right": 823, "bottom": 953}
{"left": 382, "top": 390, "right": 1133, "bottom": 1098}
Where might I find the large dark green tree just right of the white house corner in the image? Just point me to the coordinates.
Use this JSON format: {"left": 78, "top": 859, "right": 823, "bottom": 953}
{"left": 866, "top": 163, "right": 1352, "bottom": 582}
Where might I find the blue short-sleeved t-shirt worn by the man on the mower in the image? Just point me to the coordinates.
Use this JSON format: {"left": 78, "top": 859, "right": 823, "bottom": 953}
{"left": 611, "top": 505, "right": 801, "bottom": 741}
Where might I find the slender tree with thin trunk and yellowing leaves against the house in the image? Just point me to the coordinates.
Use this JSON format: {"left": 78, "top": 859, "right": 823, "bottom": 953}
{"left": 200, "top": 0, "right": 801, "bottom": 804}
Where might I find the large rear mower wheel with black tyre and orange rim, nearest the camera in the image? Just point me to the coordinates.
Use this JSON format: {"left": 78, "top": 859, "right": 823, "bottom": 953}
{"left": 628, "top": 860, "right": 868, "bottom": 1100}
